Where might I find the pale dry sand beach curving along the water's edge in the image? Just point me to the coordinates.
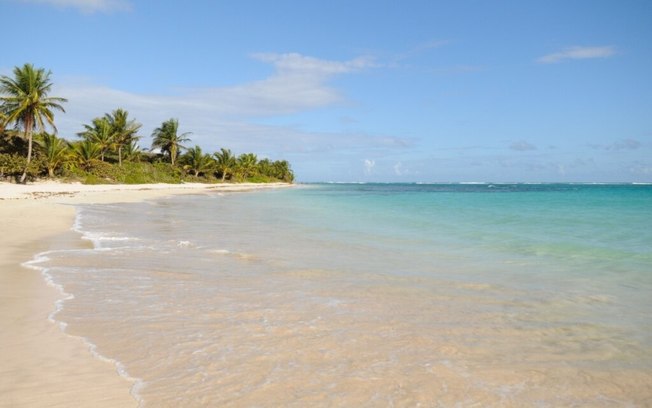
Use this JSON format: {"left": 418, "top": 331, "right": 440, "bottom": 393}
{"left": 0, "top": 183, "right": 286, "bottom": 407}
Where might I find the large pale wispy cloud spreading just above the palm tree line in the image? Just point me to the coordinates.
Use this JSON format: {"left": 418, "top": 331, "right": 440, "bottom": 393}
{"left": 53, "top": 54, "right": 414, "bottom": 161}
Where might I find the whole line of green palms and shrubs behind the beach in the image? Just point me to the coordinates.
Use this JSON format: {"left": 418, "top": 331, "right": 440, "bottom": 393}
{"left": 0, "top": 64, "right": 294, "bottom": 183}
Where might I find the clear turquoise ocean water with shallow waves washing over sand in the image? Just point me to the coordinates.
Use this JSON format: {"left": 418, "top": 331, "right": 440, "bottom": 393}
{"left": 35, "top": 183, "right": 652, "bottom": 407}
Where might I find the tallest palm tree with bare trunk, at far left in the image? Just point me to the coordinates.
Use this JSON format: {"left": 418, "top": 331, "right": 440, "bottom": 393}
{"left": 0, "top": 64, "right": 67, "bottom": 183}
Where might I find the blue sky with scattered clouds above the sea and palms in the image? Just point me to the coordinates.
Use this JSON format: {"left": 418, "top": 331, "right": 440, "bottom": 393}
{"left": 0, "top": 0, "right": 652, "bottom": 182}
